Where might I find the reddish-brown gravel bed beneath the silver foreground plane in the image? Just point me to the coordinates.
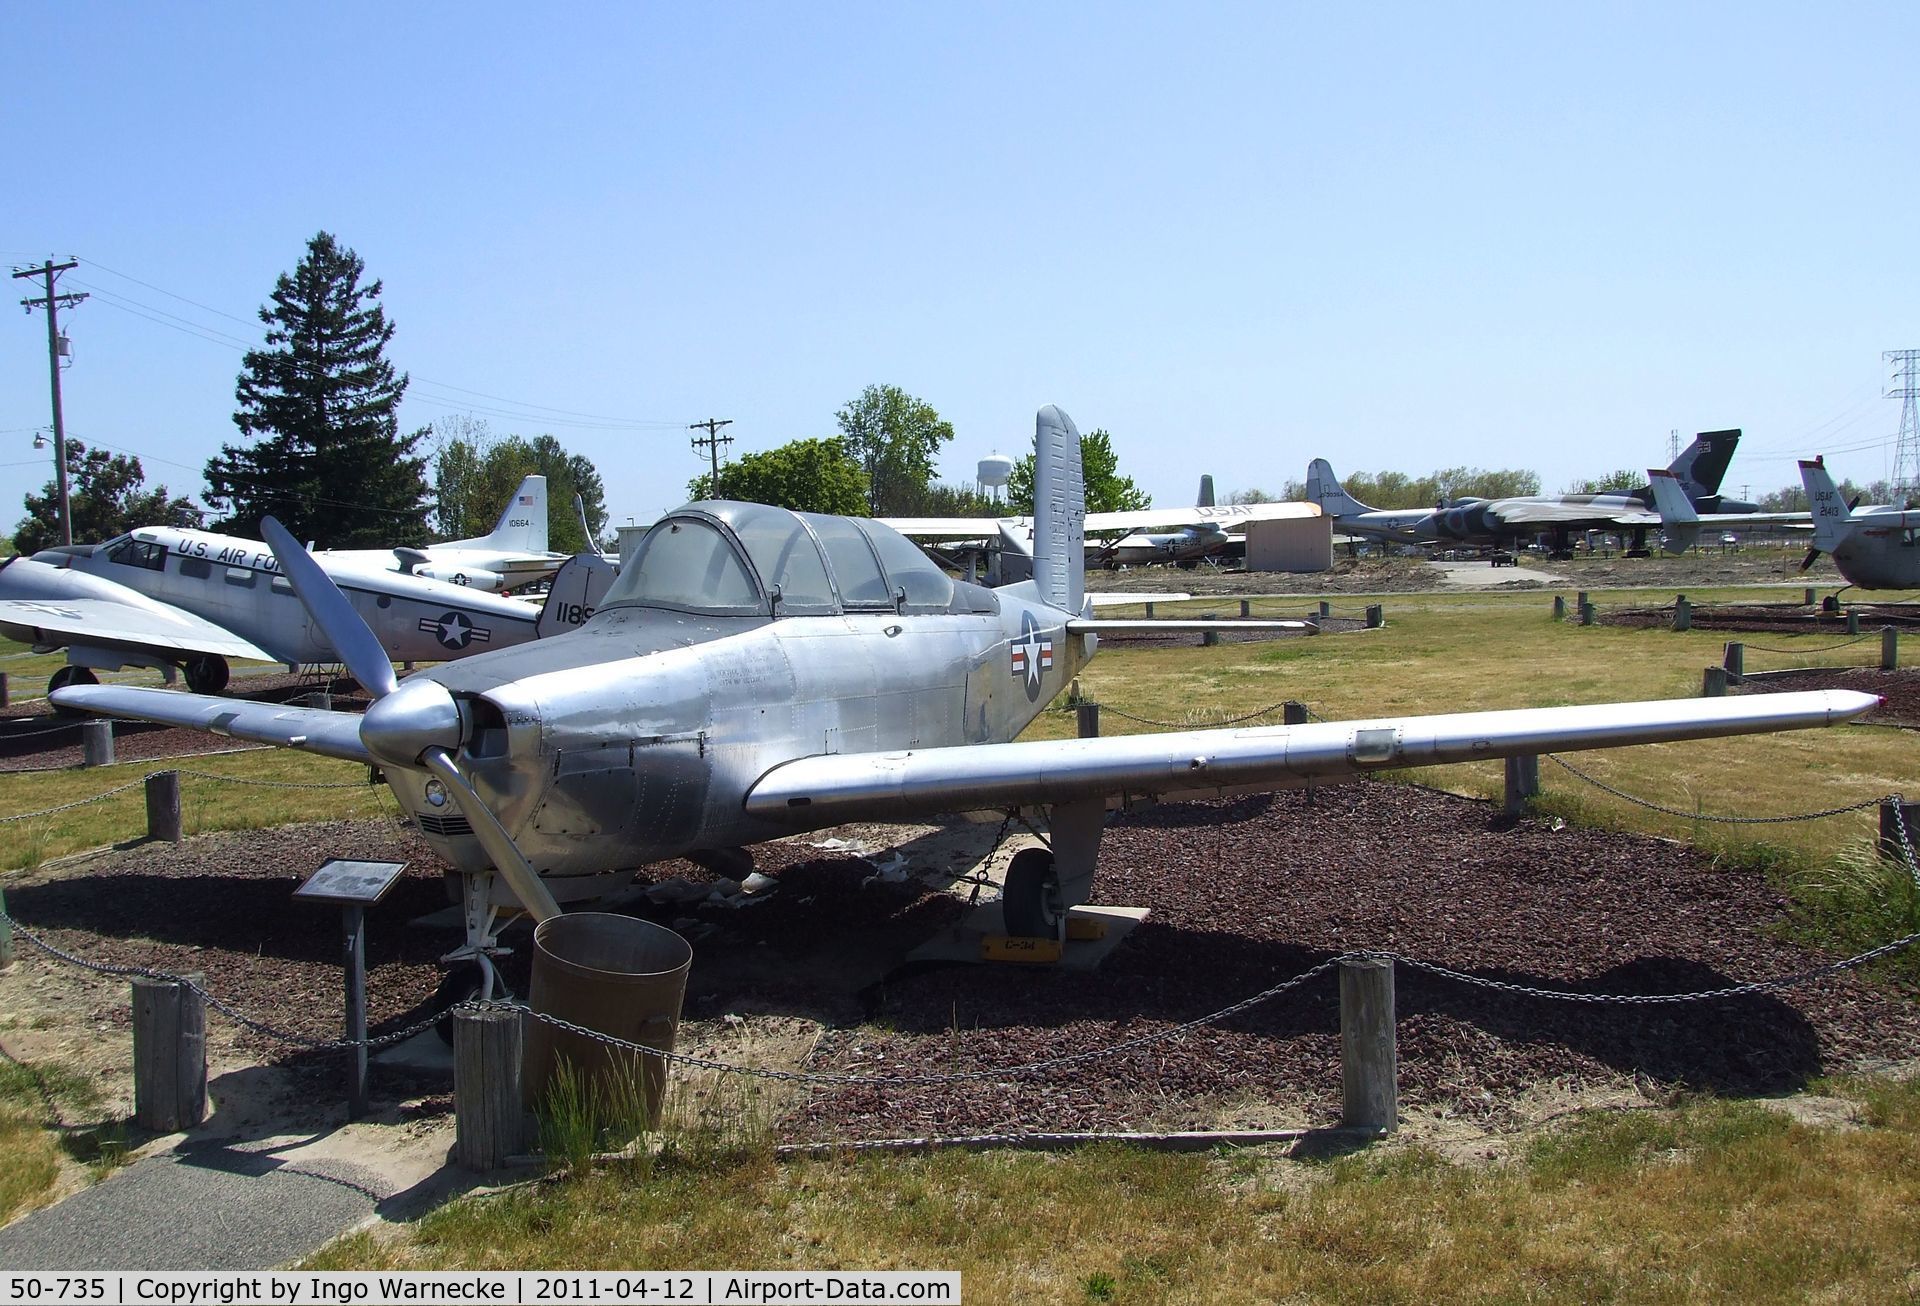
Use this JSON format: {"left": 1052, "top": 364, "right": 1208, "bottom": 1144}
{"left": 0, "top": 784, "right": 1920, "bottom": 1137}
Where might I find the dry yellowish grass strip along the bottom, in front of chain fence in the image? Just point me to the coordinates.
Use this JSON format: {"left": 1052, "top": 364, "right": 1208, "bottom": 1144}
{"left": 311, "top": 1083, "right": 1920, "bottom": 1302}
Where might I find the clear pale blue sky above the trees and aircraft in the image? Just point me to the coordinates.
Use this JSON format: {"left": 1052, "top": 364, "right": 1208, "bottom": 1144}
{"left": 0, "top": 4, "right": 1920, "bottom": 528}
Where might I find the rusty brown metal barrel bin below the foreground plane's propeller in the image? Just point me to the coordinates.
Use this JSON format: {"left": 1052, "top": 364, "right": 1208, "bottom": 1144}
{"left": 520, "top": 912, "right": 693, "bottom": 1125}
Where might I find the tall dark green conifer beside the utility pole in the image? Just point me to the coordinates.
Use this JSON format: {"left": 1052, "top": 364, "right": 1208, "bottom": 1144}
{"left": 205, "top": 230, "right": 428, "bottom": 547}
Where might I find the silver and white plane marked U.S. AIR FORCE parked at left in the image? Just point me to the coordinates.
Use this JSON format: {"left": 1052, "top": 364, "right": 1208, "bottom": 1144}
{"left": 0, "top": 526, "right": 607, "bottom": 693}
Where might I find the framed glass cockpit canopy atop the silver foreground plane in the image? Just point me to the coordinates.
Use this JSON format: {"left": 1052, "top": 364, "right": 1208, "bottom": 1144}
{"left": 601, "top": 499, "right": 954, "bottom": 617}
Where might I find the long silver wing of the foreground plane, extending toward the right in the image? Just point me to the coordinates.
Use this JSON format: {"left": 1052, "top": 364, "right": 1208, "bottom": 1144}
{"left": 747, "top": 689, "right": 1880, "bottom": 826}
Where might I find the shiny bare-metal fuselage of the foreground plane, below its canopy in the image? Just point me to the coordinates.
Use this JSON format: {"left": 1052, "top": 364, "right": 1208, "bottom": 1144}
{"left": 388, "top": 588, "right": 1094, "bottom": 876}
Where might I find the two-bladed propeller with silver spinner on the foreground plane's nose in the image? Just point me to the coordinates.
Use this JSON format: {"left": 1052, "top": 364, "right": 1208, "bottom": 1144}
{"left": 259, "top": 517, "right": 561, "bottom": 922}
